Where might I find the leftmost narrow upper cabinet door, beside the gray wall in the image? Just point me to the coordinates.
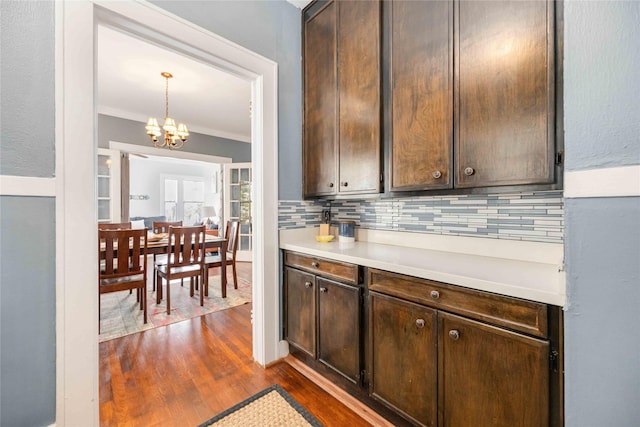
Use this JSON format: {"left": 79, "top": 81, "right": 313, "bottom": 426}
{"left": 302, "top": 3, "right": 338, "bottom": 196}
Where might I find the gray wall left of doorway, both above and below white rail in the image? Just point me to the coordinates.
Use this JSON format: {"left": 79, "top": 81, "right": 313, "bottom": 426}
{"left": 0, "top": 0, "right": 56, "bottom": 426}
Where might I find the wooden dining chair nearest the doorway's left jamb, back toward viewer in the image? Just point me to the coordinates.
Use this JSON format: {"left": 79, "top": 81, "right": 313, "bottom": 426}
{"left": 98, "top": 228, "right": 147, "bottom": 332}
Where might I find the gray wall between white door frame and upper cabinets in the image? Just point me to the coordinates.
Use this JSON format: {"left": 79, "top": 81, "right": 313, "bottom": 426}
{"left": 152, "top": 0, "right": 302, "bottom": 200}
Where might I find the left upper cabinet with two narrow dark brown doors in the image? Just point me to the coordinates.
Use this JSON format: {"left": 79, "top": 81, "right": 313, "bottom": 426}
{"left": 303, "top": 1, "right": 381, "bottom": 197}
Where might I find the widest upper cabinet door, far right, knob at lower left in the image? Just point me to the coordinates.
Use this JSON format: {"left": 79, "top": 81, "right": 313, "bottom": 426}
{"left": 455, "top": 1, "right": 554, "bottom": 188}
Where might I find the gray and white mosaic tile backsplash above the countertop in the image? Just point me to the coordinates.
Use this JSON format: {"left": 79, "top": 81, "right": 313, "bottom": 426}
{"left": 279, "top": 191, "right": 564, "bottom": 243}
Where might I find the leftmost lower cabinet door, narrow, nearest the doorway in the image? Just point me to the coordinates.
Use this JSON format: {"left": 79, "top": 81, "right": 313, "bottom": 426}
{"left": 284, "top": 267, "right": 316, "bottom": 357}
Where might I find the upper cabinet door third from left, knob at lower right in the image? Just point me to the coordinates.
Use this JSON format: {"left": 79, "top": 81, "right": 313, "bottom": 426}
{"left": 388, "top": 1, "right": 453, "bottom": 191}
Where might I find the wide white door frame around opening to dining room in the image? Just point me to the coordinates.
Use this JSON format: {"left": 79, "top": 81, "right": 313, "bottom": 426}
{"left": 55, "top": 0, "right": 286, "bottom": 426}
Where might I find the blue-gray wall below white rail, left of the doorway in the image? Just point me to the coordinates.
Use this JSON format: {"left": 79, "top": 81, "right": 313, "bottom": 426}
{"left": 0, "top": 196, "right": 56, "bottom": 427}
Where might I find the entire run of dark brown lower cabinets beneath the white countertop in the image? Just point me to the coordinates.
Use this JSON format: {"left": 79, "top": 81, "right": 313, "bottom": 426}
{"left": 284, "top": 251, "right": 563, "bottom": 427}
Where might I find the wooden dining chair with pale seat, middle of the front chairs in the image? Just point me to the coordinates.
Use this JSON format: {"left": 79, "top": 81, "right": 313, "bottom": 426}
{"left": 155, "top": 225, "right": 205, "bottom": 314}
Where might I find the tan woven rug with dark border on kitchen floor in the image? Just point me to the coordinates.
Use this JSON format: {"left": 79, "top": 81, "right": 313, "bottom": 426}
{"left": 199, "top": 384, "right": 322, "bottom": 427}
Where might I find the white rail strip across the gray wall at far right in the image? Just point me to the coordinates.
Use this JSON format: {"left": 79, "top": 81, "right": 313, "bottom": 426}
{"left": 564, "top": 165, "right": 640, "bottom": 199}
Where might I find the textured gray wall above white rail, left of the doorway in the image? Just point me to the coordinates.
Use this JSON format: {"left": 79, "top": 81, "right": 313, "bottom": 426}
{"left": 0, "top": 0, "right": 55, "bottom": 177}
